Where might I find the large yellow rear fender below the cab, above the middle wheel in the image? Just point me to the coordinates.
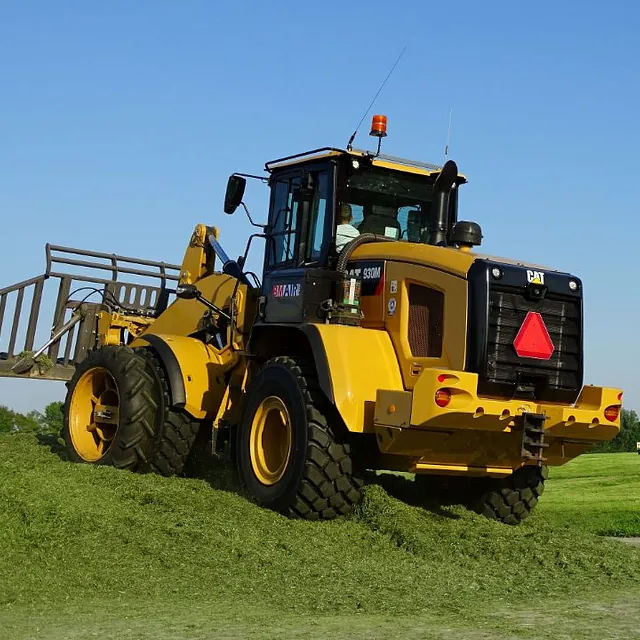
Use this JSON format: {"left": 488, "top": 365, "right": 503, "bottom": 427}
{"left": 252, "top": 324, "right": 404, "bottom": 433}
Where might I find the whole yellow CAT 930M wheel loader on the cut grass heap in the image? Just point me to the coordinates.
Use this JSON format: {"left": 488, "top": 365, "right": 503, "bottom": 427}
{"left": 0, "top": 118, "right": 622, "bottom": 524}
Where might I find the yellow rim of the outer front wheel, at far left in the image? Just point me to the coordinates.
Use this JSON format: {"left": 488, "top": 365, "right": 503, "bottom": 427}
{"left": 69, "top": 367, "right": 120, "bottom": 462}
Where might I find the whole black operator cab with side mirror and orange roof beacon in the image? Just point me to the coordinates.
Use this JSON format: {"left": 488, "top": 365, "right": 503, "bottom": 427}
{"left": 225, "top": 116, "right": 478, "bottom": 322}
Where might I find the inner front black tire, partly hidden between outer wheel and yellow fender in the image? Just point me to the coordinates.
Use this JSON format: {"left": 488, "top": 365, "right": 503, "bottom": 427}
{"left": 136, "top": 348, "right": 201, "bottom": 477}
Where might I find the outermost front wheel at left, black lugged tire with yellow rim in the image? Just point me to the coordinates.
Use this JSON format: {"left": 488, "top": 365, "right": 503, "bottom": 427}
{"left": 62, "top": 346, "right": 157, "bottom": 471}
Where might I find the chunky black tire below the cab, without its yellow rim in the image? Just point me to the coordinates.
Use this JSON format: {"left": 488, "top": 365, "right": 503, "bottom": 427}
{"left": 235, "top": 357, "right": 363, "bottom": 520}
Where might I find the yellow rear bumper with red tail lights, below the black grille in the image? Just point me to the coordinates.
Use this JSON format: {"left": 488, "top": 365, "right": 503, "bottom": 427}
{"left": 374, "top": 369, "right": 622, "bottom": 469}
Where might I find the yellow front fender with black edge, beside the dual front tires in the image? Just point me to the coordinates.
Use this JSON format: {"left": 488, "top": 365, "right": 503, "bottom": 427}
{"left": 130, "top": 333, "right": 238, "bottom": 420}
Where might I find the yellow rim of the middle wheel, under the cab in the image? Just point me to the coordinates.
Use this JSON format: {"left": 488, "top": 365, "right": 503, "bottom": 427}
{"left": 250, "top": 396, "right": 292, "bottom": 485}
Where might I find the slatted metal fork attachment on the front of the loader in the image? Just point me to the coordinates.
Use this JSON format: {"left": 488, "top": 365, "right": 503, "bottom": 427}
{"left": 0, "top": 244, "right": 180, "bottom": 380}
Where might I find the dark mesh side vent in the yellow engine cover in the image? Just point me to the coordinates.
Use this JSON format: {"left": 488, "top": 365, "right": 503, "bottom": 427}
{"left": 408, "top": 284, "right": 444, "bottom": 358}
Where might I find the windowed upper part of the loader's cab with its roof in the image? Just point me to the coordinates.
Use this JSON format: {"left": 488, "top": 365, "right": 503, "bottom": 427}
{"left": 265, "top": 147, "right": 466, "bottom": 271}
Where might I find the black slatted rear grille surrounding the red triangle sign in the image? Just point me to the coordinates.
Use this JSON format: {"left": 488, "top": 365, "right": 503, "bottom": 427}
{"left": 484, "top": 288, "right": 582, "bottom": 400}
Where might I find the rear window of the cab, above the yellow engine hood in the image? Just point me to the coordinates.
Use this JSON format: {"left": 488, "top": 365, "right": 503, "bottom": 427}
{"left": 341, "top": 167, "right": 433, "bottom": 243}
